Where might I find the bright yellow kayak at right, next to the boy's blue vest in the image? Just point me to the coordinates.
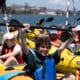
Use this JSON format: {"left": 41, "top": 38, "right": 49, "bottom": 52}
{"left": 56, "top": 49, "right": 80, "bottom": 73}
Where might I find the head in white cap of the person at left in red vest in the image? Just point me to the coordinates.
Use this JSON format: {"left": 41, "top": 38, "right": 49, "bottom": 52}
{"left": 3, "top": 32, "right": 15, "bottom": 47}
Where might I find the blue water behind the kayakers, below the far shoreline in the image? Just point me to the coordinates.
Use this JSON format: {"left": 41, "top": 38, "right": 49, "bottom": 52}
{"left": 0, "top": 15, "right": 80, "bottom": 31}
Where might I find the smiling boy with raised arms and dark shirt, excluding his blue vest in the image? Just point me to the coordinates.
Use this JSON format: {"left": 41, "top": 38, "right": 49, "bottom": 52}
{"left": 19, "top": 26, "right": 76, "bottom": 79}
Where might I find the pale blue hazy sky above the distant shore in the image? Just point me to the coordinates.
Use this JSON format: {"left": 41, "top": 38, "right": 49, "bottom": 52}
{"left": 6, "top": 0, "right": 80, "bottom": 10}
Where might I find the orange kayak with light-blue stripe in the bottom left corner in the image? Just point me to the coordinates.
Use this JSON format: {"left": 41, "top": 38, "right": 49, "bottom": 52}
{"left": 0, "top": 70, "right": 33, "bottom": 80}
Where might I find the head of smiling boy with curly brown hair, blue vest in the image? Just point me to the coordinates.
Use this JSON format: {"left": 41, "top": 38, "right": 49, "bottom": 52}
{"left": 35, "top": 36, "right": 51, "bottom": 56}
